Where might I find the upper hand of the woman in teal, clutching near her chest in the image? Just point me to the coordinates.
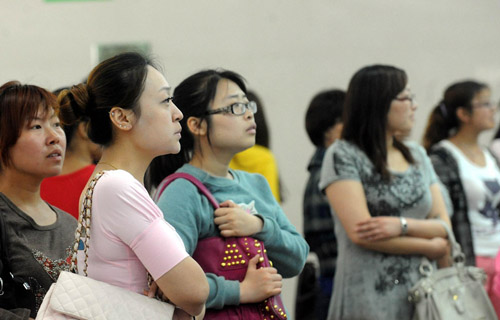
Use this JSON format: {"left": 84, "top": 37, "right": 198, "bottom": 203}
{"left": 214, "top": 200, "right": 264, "bottom": 237}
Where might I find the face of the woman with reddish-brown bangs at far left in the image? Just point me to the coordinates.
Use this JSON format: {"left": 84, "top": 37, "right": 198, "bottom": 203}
{"left": 7, "top": 108, "right": 66, "bottom": 178}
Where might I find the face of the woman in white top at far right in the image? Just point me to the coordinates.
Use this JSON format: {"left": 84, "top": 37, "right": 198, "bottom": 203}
{"left": 470, "top": 88, "right": 497, "bottom": 131}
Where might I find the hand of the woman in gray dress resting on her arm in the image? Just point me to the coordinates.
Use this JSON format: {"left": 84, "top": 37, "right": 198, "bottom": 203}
{"left": 355, "top": 217, "right": 401, "bottom": 241}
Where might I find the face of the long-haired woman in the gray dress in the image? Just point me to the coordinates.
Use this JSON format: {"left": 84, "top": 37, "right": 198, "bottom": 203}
{"left": 387, "top": 85, "right": 417, "bottom": 135}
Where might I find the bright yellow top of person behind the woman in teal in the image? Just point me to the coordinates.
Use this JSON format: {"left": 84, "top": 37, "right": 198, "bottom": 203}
{"left": 229, "top": 144, "right": 281, "bottom": 202}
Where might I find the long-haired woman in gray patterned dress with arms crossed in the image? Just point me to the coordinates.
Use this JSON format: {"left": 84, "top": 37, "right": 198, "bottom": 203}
{"left": 320, "top": 65, "right": 449, "bottom": 320}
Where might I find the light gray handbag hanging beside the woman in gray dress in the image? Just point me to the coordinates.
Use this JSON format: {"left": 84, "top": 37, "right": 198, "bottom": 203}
{"left": 408, "top": 221, "right": 497, "bottom": 320}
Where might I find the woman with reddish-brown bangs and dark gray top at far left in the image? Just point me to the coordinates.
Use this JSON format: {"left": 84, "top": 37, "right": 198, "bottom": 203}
{"left": 0, "top": 81, "right": 76, "bottom": 320}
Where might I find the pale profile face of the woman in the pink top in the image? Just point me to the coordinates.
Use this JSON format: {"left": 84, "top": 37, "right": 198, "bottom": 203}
{"left": 132, "top": 66, "right": 183, "bottom": 157}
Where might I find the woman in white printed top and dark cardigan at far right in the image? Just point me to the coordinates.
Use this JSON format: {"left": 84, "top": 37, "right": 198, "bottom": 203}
{"left": 424, "top": 81, "right": 500, "bottom": 304}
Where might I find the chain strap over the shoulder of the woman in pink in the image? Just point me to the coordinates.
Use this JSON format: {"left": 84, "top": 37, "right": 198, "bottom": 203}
{"left": 70, "top": 171, "right": 104, "bottom": 276}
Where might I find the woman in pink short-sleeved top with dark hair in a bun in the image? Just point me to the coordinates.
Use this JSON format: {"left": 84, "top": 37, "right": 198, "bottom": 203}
{"left": 59, "top": 53, "right": 208, "bottom": 316}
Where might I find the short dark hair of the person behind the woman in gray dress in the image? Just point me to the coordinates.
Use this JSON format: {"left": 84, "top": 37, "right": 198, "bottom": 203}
{"left": 306, "top": 89, "right": 346, "bottom": 147}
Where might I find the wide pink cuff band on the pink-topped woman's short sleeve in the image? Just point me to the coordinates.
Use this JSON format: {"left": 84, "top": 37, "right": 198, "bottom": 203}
{"left": 130, "top": 217, "right": 189, "bottom": 280}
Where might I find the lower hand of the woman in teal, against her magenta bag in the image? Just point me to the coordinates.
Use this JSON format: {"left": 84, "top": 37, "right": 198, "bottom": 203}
{"left": 240, "top": 255, "right": 283, "bottom": 303}
